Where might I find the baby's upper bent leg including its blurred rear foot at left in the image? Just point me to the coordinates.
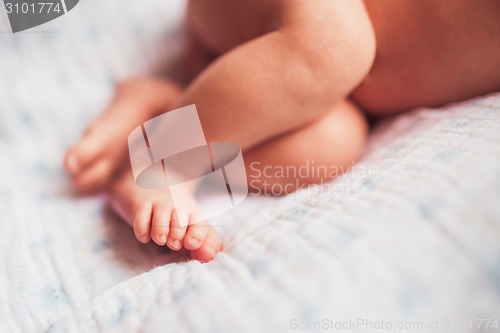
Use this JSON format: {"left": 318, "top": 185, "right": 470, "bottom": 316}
{"left": 65, "top": 0, "right": 375, "bottom": 192}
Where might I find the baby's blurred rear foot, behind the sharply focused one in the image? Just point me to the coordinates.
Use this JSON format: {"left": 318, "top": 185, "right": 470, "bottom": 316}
{"left": 64, "top": 78, "right": 180, "bottom": 192}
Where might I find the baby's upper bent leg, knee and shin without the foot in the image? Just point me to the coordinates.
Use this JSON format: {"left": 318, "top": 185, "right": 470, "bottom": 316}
{"left": 176, "top": 0, "right": 376, "bottom": 151}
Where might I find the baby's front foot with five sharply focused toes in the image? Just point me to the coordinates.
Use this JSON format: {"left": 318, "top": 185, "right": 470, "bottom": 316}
{"left": 110, "top": 165, "right": 222, "bottom": 262}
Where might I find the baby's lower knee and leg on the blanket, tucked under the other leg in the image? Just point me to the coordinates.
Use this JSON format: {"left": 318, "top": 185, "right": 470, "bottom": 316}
{"left": 244, "top": 100, "right": 368, "bottom": 195}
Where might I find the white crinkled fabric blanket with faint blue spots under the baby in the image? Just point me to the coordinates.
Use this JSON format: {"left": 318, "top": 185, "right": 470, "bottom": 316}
{"left": 0, "top": 0, "right": 500, "bottom": 333}
